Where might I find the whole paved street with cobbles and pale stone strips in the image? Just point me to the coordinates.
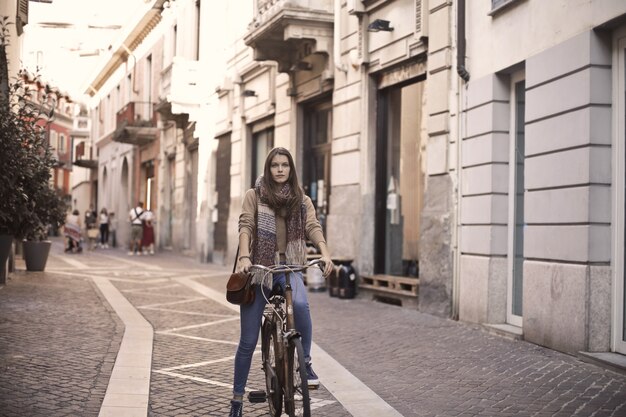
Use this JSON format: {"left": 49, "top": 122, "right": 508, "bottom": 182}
{"left": 0, "top": 237, "right": 626, "bottom": 417}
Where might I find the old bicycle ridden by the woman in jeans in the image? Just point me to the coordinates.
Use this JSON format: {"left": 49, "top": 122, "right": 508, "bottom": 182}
{"left": 249, "top": 259, "right": 321, "bottom": 417}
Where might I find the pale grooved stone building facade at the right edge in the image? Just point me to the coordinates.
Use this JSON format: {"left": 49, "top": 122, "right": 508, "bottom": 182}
{"left": 458, "top": 1, "right": 626, "bottom": 353}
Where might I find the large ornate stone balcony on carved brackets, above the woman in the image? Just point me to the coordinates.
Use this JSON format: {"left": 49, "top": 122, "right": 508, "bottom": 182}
{"left": 244, "top": 0, "right": 334, "bottom": 72}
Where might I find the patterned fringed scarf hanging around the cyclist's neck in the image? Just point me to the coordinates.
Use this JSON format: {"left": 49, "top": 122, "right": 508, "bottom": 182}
{"left": 252, "top": 176, "right": 306, "bottom": 289}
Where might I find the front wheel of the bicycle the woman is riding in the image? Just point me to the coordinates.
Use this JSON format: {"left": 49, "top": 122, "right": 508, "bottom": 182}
{"left": 285, "top": 337, "right": 311, "bottom": 417}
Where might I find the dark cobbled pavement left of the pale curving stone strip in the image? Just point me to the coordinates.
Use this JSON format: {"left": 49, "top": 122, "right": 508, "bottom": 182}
{"left": 0, "top": 242, "right": 124, "bottom": 417}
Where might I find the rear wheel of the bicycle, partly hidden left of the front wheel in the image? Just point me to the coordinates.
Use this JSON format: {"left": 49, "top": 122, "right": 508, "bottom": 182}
{"left": 261, "top": 319, "right": 283, "bottom": 417}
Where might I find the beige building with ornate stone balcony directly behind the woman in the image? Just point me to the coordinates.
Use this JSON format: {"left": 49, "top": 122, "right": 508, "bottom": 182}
{"left": 215, "top": 0, "right": 454, "bottom": 314}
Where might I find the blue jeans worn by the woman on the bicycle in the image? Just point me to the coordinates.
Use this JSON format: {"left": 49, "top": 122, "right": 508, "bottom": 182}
{"left": 233, "top": 272, "right": 313, "bottom": 395}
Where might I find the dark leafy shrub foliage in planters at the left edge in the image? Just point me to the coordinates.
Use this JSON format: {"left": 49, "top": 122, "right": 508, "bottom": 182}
{"left": 0, "top": 17, "right": 65, "bottom": 272}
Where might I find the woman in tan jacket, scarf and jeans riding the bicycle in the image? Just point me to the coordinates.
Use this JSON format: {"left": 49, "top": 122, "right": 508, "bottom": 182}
{"left": 229, "top": 148, "right": 334, "bottom": 417}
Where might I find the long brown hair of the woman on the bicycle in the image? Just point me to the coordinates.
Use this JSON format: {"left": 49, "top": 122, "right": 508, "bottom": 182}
{"left": 263, "top": 148, "right": 304, "bottom": 214}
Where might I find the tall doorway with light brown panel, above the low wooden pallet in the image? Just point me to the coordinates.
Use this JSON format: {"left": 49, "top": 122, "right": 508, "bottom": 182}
{"left": 374, "top": 82, "right": 425, "bottom": 277}
